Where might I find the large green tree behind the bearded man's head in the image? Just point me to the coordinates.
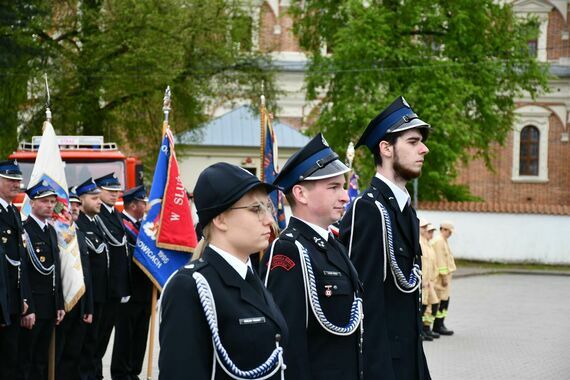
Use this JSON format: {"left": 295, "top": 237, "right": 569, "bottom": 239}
{"left": 292, "top": 0, "right": 548, "bottom": 200}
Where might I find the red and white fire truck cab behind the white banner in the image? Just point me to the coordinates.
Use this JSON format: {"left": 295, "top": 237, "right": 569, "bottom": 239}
{"left": 9, "top": 136, "right": 143, "bottom": 203}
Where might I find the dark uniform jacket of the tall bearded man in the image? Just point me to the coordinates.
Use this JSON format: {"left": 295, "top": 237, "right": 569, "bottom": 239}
{"left": 340, "top": 177, "right": 430, "bottom": 380}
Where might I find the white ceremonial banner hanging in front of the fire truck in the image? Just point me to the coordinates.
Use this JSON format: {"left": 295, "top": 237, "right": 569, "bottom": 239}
{"left": 22, "top": 120, "right": 85, "bottom": 312}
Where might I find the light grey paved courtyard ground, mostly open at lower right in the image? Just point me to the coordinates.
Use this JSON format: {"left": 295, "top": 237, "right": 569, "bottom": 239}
{"left": 105, "top": 274, "right": 570, "bottom": 380}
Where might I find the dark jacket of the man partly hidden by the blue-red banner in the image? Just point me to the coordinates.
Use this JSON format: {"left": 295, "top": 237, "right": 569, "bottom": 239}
{"left": 121, "top": 213, "right": 152, "bottom": 303}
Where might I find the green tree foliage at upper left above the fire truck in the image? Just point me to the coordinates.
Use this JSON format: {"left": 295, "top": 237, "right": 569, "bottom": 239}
{"left": 2, "top": 0, "right": 274, "bottom": 171}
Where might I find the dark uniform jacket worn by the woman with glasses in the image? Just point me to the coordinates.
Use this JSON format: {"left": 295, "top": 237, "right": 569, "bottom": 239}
{"left": 159, "top": 247, "right": 288, "bottom": 380}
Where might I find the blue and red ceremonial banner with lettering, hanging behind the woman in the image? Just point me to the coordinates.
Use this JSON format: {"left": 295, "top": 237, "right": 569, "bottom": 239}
{"left": 134, "top": 126, "right": 198, "bottom": 290}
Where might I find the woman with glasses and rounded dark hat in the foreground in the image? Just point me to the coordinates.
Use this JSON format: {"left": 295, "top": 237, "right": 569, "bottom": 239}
{"left": 159, "top": 163, "right": 288, "bottom": 380}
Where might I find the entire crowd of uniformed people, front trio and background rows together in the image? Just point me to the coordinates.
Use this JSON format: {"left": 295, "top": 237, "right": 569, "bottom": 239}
{"left": 0, "top": 97, "right": 455, "bottom": 380}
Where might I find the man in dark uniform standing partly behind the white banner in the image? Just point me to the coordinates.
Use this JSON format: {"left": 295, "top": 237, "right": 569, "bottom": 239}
{"left": 55, "top": 187, "right": 93, "bottom": 380}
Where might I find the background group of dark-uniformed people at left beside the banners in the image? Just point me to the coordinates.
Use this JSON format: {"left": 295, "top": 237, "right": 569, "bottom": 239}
{"left": 0, "top": 165, "right": 152, "bottom": 380}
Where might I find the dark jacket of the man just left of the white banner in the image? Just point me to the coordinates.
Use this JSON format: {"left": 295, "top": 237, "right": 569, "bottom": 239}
{"left": 24, "top": 216, "right": 64, "bottom": 319}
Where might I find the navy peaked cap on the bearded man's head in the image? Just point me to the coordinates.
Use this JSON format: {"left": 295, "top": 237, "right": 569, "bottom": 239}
{"left": 355, "top": 96, "right": 430, "bottom": 153}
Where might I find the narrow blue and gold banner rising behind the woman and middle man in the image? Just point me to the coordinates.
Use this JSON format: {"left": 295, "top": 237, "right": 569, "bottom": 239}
{"left": 260, "top": 105, "right": 287, "bottom": 230}
